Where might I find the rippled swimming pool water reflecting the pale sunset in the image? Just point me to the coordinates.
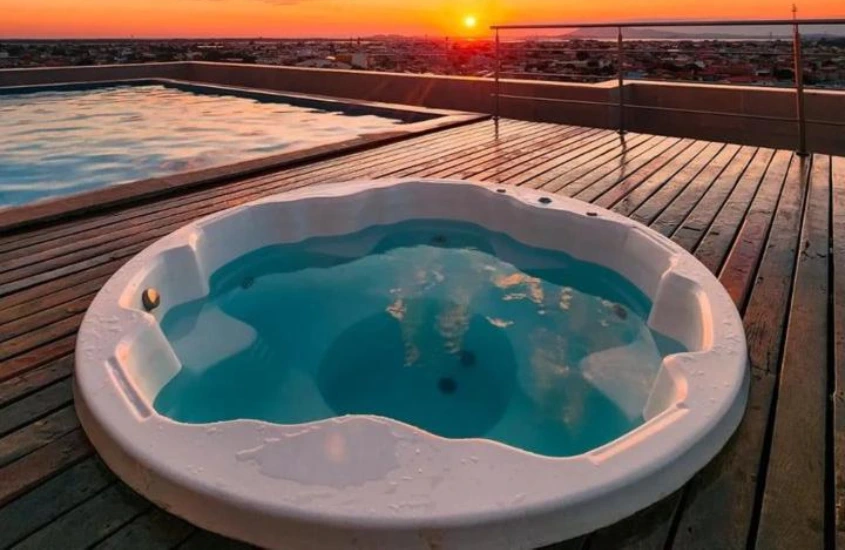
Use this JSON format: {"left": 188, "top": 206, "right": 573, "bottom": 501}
{"left": 0, "top": 85, "right": 402, "bottom": 208}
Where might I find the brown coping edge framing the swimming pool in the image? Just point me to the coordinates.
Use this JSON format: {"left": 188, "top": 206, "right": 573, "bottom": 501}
{"left": 0, "top": 78, "right": 491, "bottom": 234}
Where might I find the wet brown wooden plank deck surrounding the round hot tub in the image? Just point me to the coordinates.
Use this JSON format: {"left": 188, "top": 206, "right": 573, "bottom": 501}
{"left": 0, "top": 120, "right": 845, "bottom": 550}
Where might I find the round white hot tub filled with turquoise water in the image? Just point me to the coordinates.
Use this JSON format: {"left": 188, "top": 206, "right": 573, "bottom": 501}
{"left": 75, "top": 180, "right": 749, "bottom": 549}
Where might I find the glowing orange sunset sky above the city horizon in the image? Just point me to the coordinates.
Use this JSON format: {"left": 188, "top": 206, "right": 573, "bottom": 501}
{"left": 0, "top": 0, "right": 845, "bottom": 38}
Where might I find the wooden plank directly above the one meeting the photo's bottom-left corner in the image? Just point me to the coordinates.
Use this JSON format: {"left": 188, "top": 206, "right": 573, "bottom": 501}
{"left": 0, "top": 430, "right": 94, "bottom": 507}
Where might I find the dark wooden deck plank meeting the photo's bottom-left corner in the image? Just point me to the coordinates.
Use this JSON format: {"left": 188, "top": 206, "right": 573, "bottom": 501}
{"left": 0, "top": 457, "right": 115, "bottom": 548}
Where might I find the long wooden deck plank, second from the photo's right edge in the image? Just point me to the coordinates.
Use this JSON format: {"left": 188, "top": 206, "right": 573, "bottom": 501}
{"left": 757, "top": 156, "right": 832, "bottom": 549}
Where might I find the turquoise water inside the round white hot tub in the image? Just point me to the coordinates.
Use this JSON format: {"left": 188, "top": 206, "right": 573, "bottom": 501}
{"left": 154, "top": 220, "right": 683, "bottom": 456}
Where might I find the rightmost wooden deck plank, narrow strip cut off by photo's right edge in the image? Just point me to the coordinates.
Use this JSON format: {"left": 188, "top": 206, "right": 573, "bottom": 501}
{"left": 830, "top": 157, "right": 845, "bottom": 550}
